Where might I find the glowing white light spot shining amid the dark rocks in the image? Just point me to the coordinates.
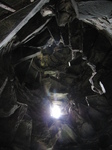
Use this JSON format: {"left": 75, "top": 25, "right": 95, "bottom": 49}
{"left": 51, "top": 104, "right": 61, "bottom": 119}
